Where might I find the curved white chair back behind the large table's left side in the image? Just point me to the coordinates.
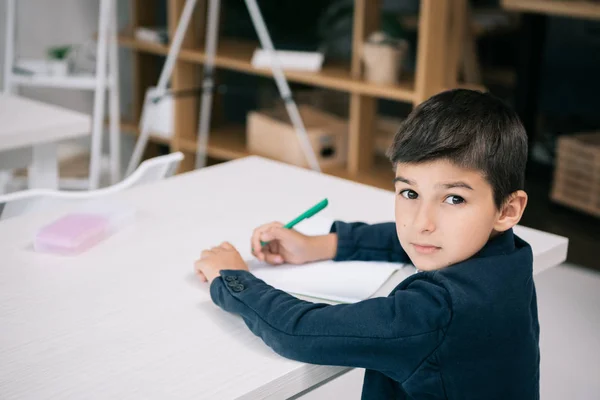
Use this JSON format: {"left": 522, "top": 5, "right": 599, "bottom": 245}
{"left": 0, "top": 152, "right": 183, "bottom": 220}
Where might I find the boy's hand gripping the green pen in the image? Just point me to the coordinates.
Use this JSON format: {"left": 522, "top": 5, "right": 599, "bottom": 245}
{"left": 251, "top": 222, "right": 337, "bottom": 265}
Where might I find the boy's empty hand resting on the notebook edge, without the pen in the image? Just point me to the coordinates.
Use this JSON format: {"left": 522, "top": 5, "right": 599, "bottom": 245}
{"left": 194, "top": 242, "right": 248, "bottom": 283}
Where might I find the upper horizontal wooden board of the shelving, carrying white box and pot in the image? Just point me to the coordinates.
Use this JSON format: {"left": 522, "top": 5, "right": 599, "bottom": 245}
{"left": 119, "top": 36, "right": 415, "bottom": 102}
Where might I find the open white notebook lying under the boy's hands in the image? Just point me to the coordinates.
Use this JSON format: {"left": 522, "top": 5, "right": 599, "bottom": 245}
{"left": 248, "top": 217, "right": 414, "bottom": 303}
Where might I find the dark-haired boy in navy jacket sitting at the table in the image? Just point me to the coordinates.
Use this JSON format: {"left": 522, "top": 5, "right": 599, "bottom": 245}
{"left": 195, "top": 90, "right": 539, "bottom": 399}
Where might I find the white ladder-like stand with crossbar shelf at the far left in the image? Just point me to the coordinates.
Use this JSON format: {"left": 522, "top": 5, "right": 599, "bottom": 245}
{"left": 3, "top": 0, "right": 121, "bottom": 190}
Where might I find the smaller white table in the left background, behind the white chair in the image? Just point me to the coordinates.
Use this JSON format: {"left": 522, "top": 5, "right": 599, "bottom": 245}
{"left": 0, "top": 94, "right": 91, "bottom": 189}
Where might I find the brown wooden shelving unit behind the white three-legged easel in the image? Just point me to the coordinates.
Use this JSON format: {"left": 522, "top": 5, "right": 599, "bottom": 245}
{"left": 124, "top": 0, "right": 466, "bottom": 189}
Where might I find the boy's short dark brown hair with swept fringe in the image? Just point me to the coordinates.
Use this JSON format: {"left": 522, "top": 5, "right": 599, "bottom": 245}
{"left": 387, "top": 89, "right": 527, "bottom": 209}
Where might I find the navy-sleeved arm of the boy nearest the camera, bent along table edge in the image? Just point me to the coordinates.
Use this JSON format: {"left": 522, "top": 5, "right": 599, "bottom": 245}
{"left": 210, "top": 270, "right": 451, "bottom": 381}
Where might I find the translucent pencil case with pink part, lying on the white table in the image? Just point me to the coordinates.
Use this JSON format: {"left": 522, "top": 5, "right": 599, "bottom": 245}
{"left": 33, "top": 206, "right": 132, "bottom": 255}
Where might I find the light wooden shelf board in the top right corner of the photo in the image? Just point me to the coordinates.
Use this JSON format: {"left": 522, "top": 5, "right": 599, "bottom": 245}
{"left": 502, "top": 0, "right": 600, "bottom": 20}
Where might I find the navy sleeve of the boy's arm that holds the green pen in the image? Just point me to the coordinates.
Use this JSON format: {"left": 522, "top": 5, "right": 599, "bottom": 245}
{"left": 331, "top": 221, "right": 410, "bottom": 263}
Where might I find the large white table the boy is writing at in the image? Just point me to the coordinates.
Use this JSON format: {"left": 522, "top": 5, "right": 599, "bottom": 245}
{"left": 0, "top": 157, "right": 562, "bottom": 399}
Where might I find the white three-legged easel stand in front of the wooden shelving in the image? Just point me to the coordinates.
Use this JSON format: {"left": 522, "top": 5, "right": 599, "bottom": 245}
{"left": 126, "top": 0, "right": 321, "bottom": 175}
